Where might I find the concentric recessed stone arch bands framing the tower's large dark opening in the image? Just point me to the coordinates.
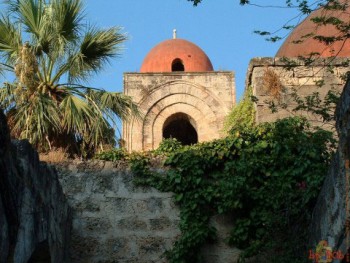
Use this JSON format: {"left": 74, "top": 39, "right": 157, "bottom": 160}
{"left": 137, "top": 81, "right": 223, "bottom": 150}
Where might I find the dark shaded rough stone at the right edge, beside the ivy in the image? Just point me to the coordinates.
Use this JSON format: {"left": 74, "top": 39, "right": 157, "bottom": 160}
{"left": 310, "top": 79, "right": 350, "bottom": 254}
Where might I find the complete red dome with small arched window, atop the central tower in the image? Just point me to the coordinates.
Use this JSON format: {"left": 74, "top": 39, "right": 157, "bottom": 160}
{"left": 140, "top": 39, "right": 213, "bottom": 73}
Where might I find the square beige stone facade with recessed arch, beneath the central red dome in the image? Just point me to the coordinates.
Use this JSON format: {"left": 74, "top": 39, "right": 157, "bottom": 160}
{"left": 123, "top": 71, "right": 235, "bottom": 151}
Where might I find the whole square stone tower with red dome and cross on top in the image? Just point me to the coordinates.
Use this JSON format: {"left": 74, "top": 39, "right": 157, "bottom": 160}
{"left": 123, "top": 30, "right": 235, "bottom": 151}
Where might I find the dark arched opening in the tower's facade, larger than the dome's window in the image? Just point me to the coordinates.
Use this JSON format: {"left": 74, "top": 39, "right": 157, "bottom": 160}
{"left": 163, "top": 112, "right": 198, "bottom": 145}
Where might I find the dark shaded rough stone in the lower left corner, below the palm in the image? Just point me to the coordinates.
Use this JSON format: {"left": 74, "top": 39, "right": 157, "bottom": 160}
{"left": 0, "top": 111, "right": 71, "bottom": 263}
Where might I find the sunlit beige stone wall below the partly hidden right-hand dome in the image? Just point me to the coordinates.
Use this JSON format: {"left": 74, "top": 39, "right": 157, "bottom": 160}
{"left": 246, "top": 58, "right": 349, "bottom": 128}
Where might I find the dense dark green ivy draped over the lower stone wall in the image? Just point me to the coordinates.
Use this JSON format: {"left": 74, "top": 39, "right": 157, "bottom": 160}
{"left": 98, "top": 118, "right": 332, "bottom": 263}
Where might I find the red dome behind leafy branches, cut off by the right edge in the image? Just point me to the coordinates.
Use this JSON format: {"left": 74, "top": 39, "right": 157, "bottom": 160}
{"left": 276, "top": 0, "right": 350, "bottom": 57}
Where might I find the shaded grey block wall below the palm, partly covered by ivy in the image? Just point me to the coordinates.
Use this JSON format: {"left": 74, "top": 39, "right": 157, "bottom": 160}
{"left": 60, "top": 161, "right": 239, "bottom": 263}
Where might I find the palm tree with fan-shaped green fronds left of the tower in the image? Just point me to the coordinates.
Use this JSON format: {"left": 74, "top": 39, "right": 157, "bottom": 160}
{"left": 0, "top": 0, "right": 138, "bottom": 157}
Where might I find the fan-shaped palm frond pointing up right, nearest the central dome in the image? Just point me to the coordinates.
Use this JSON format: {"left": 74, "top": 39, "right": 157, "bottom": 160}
{"left": 69, "top": 27, "right": 127, "bottom": 80}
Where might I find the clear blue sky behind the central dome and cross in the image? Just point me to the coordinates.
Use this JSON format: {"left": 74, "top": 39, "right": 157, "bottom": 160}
{"left": 85, "top": 0, "right": 297, "bottom": 100}
